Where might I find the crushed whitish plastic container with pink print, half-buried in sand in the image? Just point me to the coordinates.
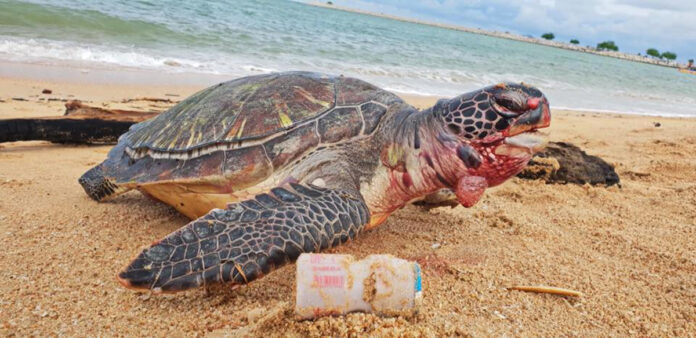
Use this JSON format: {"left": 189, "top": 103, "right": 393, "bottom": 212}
{"left": 295, "top": 254, "right": 423, "bottom": 319}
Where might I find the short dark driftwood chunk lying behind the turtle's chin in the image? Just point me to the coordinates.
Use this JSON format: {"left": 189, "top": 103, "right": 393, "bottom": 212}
{"left": 517, "top": 142, "right": 621, "bottom": 187}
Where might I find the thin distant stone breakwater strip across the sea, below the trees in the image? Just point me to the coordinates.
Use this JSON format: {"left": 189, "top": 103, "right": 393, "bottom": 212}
{"left": 308, "top": 1, "right": 686, "bottom": 69}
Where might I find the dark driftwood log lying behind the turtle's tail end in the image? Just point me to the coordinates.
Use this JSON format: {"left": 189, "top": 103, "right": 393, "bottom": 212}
{"left": 0, "top": 101, "right": 159, "bottom": 144}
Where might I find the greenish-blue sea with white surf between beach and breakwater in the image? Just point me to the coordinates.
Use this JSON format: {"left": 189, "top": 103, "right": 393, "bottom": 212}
{"left": 0, "top": 0, "right": 696, "bottom": 117}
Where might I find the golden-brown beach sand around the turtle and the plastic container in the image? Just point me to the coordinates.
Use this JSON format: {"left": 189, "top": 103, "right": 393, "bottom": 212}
{"left": 0, "top": 68, "right": 696, "bottom": 336}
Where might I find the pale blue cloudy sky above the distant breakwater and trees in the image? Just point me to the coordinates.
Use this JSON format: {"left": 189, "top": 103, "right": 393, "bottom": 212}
{"left": 316, "top": 0, "right": 696, "bottom": 61}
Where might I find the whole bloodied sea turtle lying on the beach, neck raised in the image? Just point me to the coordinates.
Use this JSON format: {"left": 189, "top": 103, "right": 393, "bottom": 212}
{"left": 79, "top": 72, "right": 551, "bottom": 292}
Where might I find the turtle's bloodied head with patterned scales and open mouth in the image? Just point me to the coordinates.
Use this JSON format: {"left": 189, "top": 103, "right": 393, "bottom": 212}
{"left": 432, "top": 83, "right": 551, "bottom": 206}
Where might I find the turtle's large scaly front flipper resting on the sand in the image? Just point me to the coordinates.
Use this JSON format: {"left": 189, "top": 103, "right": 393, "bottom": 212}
{"left": 118, "top": 183, "right": 370, "bottom": 292}
